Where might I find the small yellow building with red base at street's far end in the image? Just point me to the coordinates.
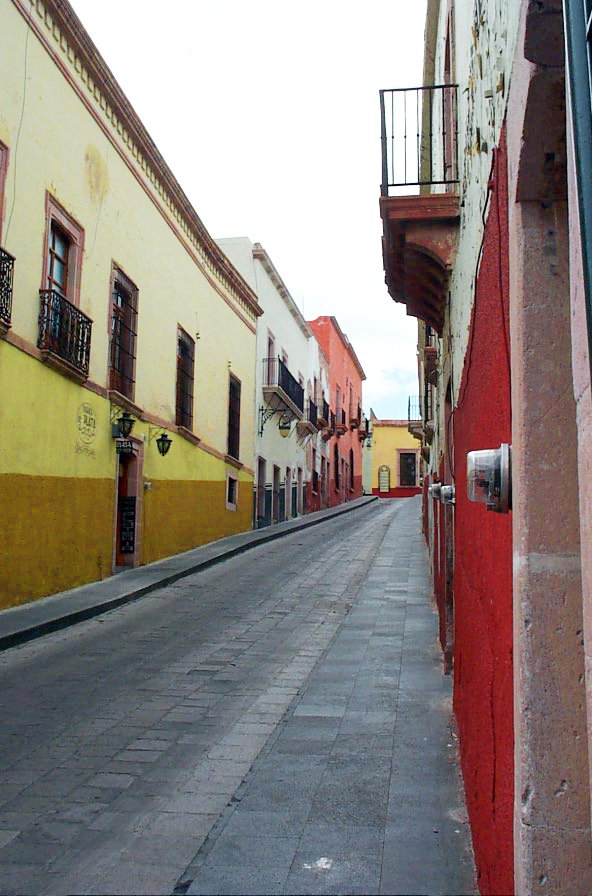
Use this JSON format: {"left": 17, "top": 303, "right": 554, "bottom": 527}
{"left": 371, "top": 418, "right": 421, "bottom": 498}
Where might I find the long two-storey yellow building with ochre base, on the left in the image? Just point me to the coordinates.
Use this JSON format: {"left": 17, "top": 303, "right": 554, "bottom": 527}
{"left": 0, "top": 0, "right": 261, "bottom": 607}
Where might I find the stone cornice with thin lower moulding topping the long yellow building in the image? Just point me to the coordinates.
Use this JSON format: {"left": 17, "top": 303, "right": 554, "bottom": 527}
{"left": 12, "top": 0, "right": 263, "bottom": 321}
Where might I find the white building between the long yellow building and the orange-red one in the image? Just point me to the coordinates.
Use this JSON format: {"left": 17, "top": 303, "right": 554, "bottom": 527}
{"left": 218, "top": 237, "right": 328, "bottom": 528}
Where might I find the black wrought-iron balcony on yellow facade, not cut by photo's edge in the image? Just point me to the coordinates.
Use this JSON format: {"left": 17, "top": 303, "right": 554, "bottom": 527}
{"left": 37, "top": 289, "right": 92, "bottom": 382}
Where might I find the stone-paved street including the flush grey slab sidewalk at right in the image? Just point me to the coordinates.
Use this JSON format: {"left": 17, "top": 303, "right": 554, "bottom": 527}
{"left": 0, "top": 499, "right": 476, "bottom": 896}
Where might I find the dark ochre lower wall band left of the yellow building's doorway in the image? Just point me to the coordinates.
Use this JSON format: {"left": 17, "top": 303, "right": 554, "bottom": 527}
{"left": 0, "top": 474, "right": 115, "bottom": 609}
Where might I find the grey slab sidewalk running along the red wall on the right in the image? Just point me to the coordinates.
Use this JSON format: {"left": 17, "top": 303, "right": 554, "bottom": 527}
{"left": 180, "top": 499, "right": 477, "bottom": 896}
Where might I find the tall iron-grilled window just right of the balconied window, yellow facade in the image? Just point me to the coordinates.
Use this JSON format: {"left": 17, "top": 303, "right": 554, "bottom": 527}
{"left": 109, "top": 268, "right": 138, "bottom": 399}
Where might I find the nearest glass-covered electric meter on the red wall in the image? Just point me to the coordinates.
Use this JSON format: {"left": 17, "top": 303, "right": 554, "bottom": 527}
{"left": 467, "top": 443, "right": 512, "bottom": 513}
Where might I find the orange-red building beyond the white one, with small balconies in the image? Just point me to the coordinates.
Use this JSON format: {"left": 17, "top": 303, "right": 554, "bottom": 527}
{"left": 308, "top": 317, "right": 366, "bottom": 507}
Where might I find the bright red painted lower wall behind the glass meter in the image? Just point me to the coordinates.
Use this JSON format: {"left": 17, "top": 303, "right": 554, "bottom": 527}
{"left": 453, "top": 134, "right": 514, "bottom": 896}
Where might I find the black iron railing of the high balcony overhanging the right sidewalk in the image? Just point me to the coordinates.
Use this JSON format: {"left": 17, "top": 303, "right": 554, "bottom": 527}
{"left": 380, "top": 84, "right": 459, "bottom": 196}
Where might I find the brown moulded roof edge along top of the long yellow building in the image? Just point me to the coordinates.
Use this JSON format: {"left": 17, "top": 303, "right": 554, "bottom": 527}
{"left": 20, "top": 0, "right": 263, "bottom": 318}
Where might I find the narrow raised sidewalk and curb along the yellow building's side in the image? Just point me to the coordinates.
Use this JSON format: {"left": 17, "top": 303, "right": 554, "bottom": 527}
{"left": 0, "top": 496, "right": 378, "bottom": 650}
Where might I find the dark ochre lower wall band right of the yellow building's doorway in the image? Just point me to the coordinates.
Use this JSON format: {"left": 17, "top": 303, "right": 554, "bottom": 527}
{"left": 142, "top": 479, "right": 253, "bottom": 563}
